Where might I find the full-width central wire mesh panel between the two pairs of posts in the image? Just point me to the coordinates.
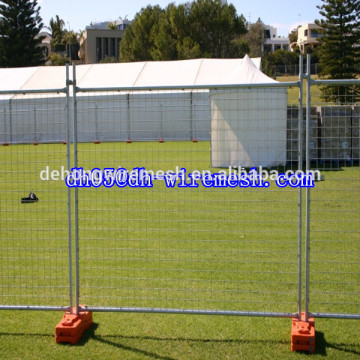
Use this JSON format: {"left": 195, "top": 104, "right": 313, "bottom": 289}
{"left": 76, "top": 89, "right": 299, "bottom": 315}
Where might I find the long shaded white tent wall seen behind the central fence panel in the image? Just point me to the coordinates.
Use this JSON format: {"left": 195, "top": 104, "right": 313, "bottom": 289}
{"left": 77, "top": 91, "right": 210, "bottom": 142}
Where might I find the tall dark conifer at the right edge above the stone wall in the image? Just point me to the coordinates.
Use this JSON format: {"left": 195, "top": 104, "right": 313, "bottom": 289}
{"left": 316, "top": 0, "right": 360, "bottom": 103}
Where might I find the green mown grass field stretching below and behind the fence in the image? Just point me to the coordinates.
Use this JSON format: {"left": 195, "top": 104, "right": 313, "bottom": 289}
{"left": 0, "top": 142, "right": 360, "bottom": 359}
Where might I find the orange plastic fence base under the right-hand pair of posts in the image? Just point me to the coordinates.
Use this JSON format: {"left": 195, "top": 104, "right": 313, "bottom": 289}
{"left": 291, "top": 313, "right": 315, "bottom": 354}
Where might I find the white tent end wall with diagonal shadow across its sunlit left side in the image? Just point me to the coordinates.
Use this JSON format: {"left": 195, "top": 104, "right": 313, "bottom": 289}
{"left": 210, "top": 88, "right": 287, "bottom": 168}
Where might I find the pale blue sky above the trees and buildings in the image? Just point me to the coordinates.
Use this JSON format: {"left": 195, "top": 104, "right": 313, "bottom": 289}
{"left": 38, "top": 0, "right": 322, "bottom": 36}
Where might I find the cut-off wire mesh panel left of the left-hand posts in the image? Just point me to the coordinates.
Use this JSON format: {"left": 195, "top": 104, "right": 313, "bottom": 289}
{"left": 0, "top": 91, "right": 69, "bottom": 307}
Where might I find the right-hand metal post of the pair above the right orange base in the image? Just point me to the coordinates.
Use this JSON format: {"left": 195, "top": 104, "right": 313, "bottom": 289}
{"left": 305, "top": 54, "right": 311, "bottom": 322}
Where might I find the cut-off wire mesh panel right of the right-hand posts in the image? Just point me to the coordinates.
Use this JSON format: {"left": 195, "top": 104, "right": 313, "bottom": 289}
{"left": 309, "top": 84, "right": 360, "bottom": 316}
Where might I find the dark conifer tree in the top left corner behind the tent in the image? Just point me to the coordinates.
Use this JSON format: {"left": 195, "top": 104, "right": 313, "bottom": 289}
{"left": 0, "top": 0, "right": 45, "bottom": 67}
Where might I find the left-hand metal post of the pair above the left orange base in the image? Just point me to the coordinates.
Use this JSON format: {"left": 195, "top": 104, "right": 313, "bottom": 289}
{"left": 66, "top": 64, "right": 73, "bottom": 314}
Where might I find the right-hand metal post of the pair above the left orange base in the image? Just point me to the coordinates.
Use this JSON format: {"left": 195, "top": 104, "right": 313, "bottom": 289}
{"left": 73, "top": 63, "right": 79, "bottom": 314}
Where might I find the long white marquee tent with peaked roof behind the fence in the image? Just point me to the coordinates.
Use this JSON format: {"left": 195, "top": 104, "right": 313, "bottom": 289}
{"left": 0, "top": 56, "right": 286, "bottom": 166}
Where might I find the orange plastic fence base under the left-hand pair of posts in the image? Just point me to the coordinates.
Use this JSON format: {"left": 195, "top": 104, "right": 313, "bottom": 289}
{"left": 55, "top": 308, "right": 92, "bottom": 344}
